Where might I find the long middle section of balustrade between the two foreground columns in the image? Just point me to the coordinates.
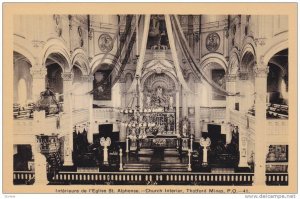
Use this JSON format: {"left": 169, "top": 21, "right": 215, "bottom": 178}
{"left": 50, "top": 172, "right": 253, "bottom": 185}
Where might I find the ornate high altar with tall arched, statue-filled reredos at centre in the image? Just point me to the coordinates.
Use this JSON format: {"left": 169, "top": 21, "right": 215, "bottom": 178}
{"left": 127, "top": 50, "right": 190, "bottom": 151}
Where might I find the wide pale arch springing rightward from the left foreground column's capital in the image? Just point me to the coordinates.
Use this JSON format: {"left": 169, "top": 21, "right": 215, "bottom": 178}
{"left": 41, "top": 39, "right": 71, "bottom": 72}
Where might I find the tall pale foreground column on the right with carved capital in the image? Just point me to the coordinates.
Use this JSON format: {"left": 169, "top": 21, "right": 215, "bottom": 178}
{"left": 254, "top": 65, "right": 269, "bottom": 185}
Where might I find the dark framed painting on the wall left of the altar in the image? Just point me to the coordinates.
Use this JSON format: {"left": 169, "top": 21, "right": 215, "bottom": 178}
{"left": 93, "top": 70, "right": 111, "bottom": 100}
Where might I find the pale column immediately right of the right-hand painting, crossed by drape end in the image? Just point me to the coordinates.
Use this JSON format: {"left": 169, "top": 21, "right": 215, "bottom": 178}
{"left": 226, "top": 74, "right": 236, "bottom": 122}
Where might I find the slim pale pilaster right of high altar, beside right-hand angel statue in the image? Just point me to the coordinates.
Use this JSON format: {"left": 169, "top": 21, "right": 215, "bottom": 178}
{"left": 194, "top": 82, "right": 202, "bottom": 140}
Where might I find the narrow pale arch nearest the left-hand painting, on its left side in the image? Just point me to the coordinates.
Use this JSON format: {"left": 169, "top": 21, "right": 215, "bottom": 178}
{"left": 71, "top": 48, "right": 90, "bottom": 75}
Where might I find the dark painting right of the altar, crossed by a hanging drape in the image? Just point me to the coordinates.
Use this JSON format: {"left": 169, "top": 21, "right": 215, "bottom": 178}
{"left": 211, "top": 69, "right": 226, "bottom": 100}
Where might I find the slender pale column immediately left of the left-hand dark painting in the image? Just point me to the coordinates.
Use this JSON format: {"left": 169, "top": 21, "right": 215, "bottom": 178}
{"left": 81, "top": 75, "right": 94, "bottom": 143}
